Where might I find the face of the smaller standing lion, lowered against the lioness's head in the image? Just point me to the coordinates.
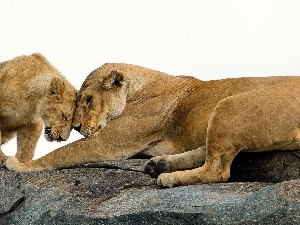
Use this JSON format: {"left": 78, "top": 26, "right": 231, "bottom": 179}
{"left": 40, "top": 78, "right": 76, "bottom": 142}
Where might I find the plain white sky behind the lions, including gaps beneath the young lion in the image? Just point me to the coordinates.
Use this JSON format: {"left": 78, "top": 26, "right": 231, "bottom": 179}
{"left": 0, "top": 0, "right": 300, "bottom": 158}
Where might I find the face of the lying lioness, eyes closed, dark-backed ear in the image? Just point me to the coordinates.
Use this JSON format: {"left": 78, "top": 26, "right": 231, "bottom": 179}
{"left": 73, "top": 70, "right": 127, "bottom": 137}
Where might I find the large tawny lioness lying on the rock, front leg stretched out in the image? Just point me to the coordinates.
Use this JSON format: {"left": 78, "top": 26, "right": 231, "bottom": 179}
{"left": 6, "top": 64, "right": 300, "bottom": 187}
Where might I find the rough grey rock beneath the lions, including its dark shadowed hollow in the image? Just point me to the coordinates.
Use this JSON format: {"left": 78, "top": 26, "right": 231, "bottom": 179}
{"left": 0, "top": 152, "right": 300, "bottom": 225}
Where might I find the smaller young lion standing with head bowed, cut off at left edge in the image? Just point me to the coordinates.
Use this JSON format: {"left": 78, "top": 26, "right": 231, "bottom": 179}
{"left": 0, "top": 53, "right": 77, "bottom": 165}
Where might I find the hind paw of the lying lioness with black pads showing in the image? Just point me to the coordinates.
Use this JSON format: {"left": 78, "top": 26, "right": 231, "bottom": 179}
{"left": 144, "top": 156, "right": 169, "bottom": 178}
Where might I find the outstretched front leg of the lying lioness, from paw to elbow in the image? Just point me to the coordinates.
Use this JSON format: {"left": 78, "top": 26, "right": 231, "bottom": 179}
{"left": 5, "top": 133, "right": 145, "bottom": 172}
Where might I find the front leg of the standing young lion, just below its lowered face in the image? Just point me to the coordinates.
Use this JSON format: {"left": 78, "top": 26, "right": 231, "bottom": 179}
{"left": 16, "top": 122, "right": 43, "bottom": 162}
